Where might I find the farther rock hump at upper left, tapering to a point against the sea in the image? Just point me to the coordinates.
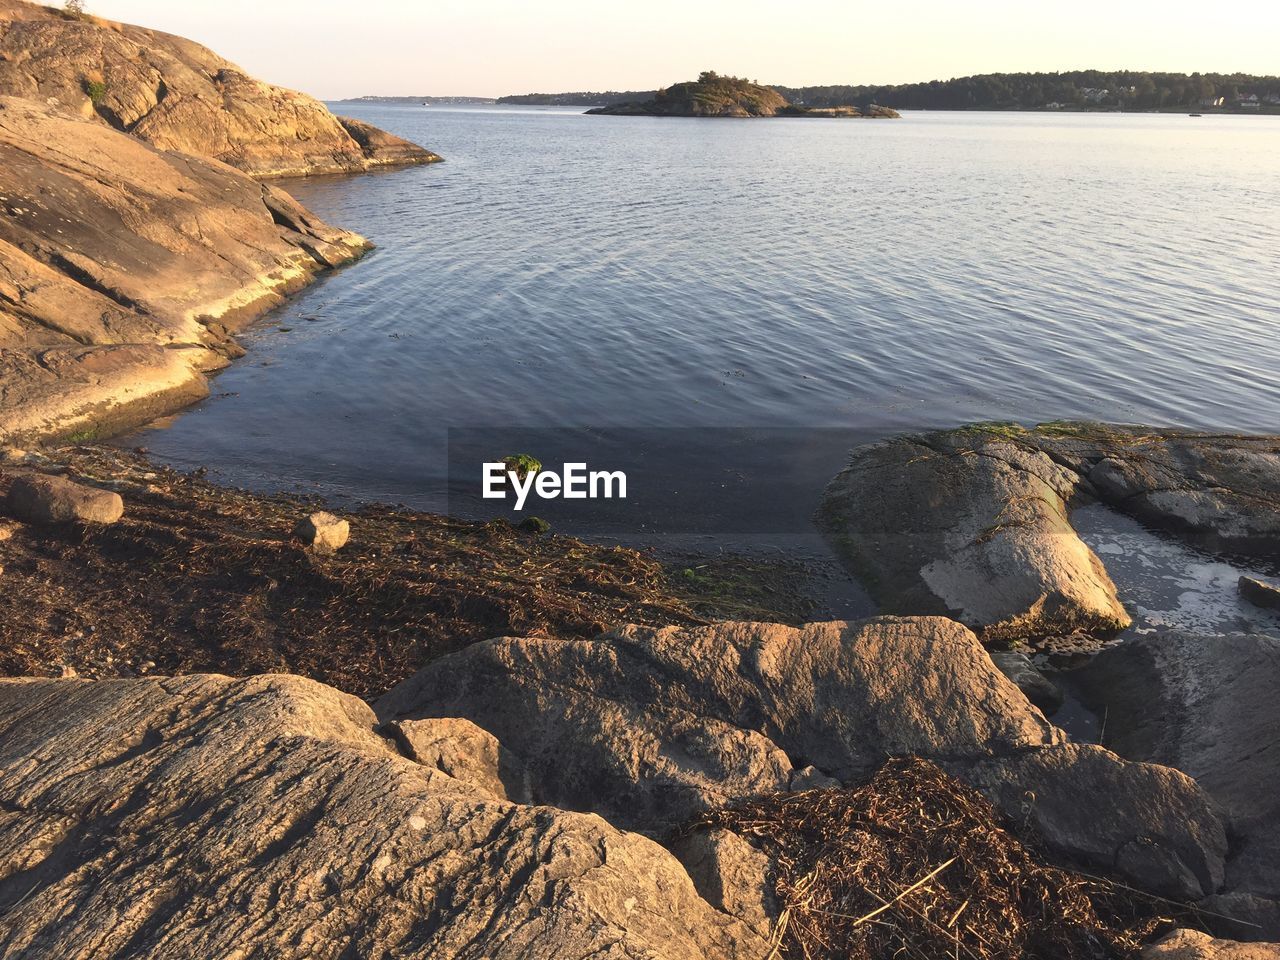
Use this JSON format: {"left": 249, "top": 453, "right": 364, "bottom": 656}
{"left": 0, "top": 0, "right": 440, "bottom": 177}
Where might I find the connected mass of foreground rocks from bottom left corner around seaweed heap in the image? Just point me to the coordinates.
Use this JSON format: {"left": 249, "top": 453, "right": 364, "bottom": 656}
{"left": 0, "top": 618, "right": 1269, "bottom": 960}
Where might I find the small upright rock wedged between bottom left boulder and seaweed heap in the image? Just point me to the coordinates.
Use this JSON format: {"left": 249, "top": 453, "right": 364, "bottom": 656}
{"left": 672, "top": 828, "right": 778, "bottom": 938}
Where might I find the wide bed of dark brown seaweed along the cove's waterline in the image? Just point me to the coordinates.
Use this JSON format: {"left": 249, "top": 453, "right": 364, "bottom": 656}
{"left": 0, "top": 445, "right": 809, "bottom": 698}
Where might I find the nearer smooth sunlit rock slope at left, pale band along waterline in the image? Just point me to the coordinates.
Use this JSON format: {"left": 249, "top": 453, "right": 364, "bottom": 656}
{"left": 0, "top": 97, "right": 369, "bottom": 443}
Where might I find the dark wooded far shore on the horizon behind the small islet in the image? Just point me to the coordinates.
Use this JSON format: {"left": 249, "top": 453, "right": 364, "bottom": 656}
{"left": 498, "top": 70, "right": 1280, "bottom": 113}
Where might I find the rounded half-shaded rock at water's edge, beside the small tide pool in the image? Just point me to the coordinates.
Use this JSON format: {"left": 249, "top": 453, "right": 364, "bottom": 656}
{"left": 820, "top": 430, "right": 1130, "bottom": 641}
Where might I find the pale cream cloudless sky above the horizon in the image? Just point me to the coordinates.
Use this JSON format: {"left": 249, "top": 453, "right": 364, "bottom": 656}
{"left": 85, "top": 0, "right": 1280, "bottom": 99}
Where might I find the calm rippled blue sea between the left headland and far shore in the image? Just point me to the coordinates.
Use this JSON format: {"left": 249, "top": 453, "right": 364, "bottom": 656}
{"left": 132, "top": 105, "right": 1280, "bottom": 535}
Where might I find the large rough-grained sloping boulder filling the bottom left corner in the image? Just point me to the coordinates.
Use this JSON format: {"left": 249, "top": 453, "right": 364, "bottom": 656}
{"left": 0, "top": 676, "right": 768, "bottom": 960}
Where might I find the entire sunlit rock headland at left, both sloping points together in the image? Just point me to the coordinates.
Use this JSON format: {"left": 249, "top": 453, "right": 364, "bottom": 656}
{"left": 0, "top": 0, "right": 440, "bottom": 443}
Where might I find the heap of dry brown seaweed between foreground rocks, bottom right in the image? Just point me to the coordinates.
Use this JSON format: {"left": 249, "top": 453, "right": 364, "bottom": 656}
{"left": 687, "top": 758, "right": 1192, "bottom": 960}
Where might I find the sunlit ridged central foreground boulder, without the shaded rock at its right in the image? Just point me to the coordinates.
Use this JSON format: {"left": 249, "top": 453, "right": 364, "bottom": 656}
{"left": 376, "top": 618, "right": 1061, "bottom": 831}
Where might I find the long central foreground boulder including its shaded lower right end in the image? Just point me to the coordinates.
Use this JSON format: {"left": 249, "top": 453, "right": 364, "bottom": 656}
{"left": 375, "top": 617, "right": 1226, "bottom": 899}
